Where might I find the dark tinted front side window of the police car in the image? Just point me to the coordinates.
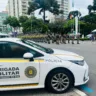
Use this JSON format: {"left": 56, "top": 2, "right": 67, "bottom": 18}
{"left": 0, "top": 42, "right": 43, "bottom": 58}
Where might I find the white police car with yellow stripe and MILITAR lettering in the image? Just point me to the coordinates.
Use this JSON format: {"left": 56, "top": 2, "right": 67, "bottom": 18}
{"left": 0, "top": 38, "right": 89, "bottom": 93}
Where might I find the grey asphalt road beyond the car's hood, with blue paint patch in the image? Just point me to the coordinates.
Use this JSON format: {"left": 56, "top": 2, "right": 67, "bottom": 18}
{"left": 39, "top": 41, "right": 96, "bottom": 96}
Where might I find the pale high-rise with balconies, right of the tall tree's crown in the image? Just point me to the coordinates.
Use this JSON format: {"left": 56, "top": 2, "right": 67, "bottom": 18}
{"left": 55, "top": 0, "right": 69, "bottom": 20}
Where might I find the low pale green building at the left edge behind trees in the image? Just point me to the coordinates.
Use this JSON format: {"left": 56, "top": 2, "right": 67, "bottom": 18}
{"left": 0, "top": 12, "right": 11, "bottom": 33}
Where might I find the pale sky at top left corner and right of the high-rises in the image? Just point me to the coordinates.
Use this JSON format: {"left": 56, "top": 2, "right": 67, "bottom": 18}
{"left": 0, "top": 0, "right": 93, "bottom": 16}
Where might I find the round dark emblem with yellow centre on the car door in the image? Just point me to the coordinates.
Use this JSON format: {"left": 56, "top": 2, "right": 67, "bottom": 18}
{"left": 25, "top": 66, "right": 37, "bottom": 78}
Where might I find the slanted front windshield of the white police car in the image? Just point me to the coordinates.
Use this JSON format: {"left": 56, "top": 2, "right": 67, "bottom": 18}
{"left": 22, "top": 40, "right": 54, "bottom": 54}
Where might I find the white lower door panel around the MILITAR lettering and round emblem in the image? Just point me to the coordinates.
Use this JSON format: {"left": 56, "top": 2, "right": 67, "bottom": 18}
{"left": 0, "top": 59, "right": 40, "bottom": 85}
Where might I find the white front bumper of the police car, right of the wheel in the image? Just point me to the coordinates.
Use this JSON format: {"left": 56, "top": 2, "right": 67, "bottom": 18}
{"left": 69, "top": 62, "right": 89, "bottom": 86}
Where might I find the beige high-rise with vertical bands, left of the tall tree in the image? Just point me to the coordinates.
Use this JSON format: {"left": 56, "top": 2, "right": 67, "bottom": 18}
{"left": 7, "top": 0, "right": 29, "bottom": 18}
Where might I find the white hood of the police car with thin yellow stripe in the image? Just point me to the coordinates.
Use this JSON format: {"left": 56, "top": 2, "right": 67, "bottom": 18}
{"left": 52, "top": 49, "right": 84, "bottom": 60}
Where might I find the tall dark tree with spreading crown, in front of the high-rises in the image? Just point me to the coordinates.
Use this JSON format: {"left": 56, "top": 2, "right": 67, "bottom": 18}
{"left": 28, "top": 0, "right": 63, "bottom": 22}
